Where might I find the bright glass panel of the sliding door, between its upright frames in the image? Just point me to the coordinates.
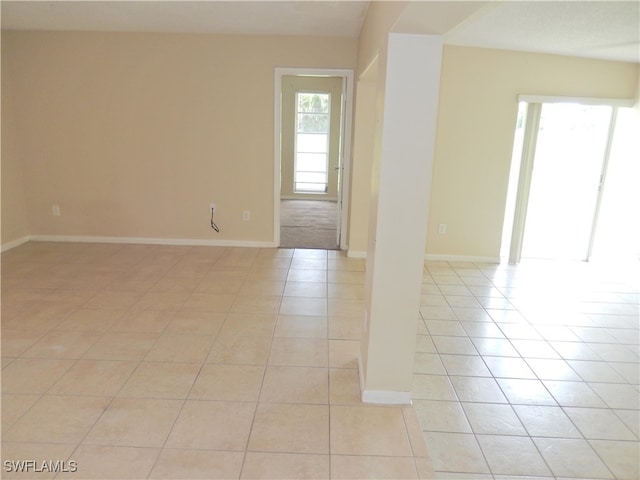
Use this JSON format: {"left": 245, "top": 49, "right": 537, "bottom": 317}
{"left": 522, "top": 103, "right": 612, "bottom": 260}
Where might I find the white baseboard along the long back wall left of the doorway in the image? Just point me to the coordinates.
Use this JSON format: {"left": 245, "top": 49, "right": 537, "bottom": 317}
{"left": 28, "top": 235, "right": 275, "bottom": 248}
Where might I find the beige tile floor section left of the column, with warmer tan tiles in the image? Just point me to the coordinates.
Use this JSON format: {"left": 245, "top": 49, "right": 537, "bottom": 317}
{"left": 1, "top": 243, "right": 433, "bottom": 479}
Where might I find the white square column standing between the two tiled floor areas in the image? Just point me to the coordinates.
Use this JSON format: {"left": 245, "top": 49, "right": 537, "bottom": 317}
{"left": 359, "top": 33, "right": 442, "bottom": 404}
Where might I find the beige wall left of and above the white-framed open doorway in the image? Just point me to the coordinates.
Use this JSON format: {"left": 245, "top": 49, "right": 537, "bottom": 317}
{"left": 2, "top": 32, "right": 357, "bottom": 243}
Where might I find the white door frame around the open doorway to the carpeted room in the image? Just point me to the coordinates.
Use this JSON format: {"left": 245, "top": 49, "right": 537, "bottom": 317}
{"left": 273, "top": 68, "right": 353, "bottom": 250}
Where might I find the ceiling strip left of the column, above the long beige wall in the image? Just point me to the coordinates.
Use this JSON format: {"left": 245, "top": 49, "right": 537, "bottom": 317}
{"left": 2, "top": 0, "right": 369, "bottom": 37}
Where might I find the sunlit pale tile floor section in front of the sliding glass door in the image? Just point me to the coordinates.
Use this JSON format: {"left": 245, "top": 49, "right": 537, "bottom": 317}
{"left": 414, "top": 262, "right": 640, "bottom": 480}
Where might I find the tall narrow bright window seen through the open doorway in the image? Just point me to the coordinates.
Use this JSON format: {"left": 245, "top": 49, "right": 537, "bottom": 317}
{"left": 293, "top": 92, "right": 331, "bottom": 194}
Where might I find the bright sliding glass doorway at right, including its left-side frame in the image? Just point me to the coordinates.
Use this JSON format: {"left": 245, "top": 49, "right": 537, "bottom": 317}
{"left": 502, "top": 97, "right": 636, "bottom": 263}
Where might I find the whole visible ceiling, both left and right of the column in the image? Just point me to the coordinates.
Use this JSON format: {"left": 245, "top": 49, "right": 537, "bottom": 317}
{"left": 1, "top": 0, "right": 640, "bottom": 63}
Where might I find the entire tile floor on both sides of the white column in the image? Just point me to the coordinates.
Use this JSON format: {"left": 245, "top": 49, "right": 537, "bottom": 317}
{"left": 2, "top": 243, "right": 640, "bottom": 480}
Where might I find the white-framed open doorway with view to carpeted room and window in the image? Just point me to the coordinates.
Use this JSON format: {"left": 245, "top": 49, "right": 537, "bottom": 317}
{"left": 274, "top": 69, "right": 352, "bottom": 249}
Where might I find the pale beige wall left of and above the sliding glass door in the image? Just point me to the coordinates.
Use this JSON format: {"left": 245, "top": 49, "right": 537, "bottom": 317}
{"left": 426, "top": 46, "right": 638, "bottom": 258}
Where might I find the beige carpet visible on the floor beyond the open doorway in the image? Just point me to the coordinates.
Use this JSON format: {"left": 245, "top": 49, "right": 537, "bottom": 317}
{"left": 280, "top": 200, "right": 338, "bottom": 250}
